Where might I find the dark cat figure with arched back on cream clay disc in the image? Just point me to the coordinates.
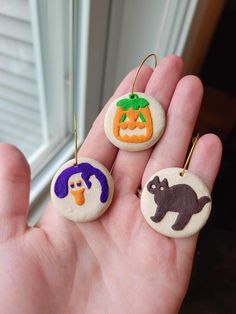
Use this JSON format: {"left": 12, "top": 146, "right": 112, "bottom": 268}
{"left": 147, "top": 176, "right": 211, "bottom": 230}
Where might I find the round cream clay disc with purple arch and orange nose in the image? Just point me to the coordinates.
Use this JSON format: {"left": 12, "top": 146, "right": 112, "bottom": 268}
{"left": 51, "top": 158, "right": 114, "bottom": 222}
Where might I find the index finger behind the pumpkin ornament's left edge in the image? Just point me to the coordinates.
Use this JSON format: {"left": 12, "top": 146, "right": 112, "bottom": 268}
{"left": 78, "top": 67, "right": 152, "bottom": 169}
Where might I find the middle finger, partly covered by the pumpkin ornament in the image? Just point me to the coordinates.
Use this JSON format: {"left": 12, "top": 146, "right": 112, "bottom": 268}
{"left": 113, "top": 56, "right": 183, "bottom": 192}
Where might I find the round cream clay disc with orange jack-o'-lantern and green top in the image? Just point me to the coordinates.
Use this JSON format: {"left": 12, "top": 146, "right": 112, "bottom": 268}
{"left": 104, "top": 92, "right": 165, "bottom": 151}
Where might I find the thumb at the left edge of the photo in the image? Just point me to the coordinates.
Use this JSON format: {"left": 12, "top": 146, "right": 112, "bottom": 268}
{"left": 0, "top": 144, "right": 30, "bottom": 242}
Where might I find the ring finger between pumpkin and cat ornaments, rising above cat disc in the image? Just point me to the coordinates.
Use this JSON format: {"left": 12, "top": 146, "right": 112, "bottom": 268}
{"left": 142, "top": 76, "right": 203, "bottom": 184}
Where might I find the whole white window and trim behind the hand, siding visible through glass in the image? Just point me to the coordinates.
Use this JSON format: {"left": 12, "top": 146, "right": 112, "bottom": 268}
{"left": 0, "top": 0, "right": 201, "bottom": 221}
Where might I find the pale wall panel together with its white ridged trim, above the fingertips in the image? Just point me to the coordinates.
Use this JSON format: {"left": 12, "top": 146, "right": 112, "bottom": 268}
{"left": 103, "top": 0, "right": 199, "bottom": 102}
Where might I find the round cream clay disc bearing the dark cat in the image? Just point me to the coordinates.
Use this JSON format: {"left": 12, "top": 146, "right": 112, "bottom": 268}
{"left": 141, "top": 168, "right": 211, "bottom": 238}
